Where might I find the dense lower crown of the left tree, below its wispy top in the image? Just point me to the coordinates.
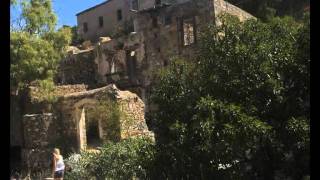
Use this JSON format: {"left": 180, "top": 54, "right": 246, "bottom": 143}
{"left": 10, "top": 26, "right": 71, "bottom": 89}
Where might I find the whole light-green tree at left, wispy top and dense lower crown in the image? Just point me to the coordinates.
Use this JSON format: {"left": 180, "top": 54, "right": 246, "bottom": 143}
{"left": 10, "top": 0, "right": 71, "bottom": 90}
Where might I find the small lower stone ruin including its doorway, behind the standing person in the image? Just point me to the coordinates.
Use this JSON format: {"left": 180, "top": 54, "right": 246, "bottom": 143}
{"left": 21, "top": 85, "right": 153, "bottom": 171}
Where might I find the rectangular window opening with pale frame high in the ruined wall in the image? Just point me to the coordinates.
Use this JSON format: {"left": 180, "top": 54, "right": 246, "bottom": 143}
{"left": 182, "top": 18, "right": 196, "bottom": 46}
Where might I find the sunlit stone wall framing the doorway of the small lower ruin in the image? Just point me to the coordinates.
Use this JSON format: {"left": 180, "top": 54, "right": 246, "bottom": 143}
{"left": 56, "top": 85, "right": 151, "bottom": 149}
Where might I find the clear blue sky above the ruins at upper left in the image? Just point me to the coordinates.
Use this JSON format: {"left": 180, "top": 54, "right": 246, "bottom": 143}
{"left": 11, "top": 0, "right": 106, "bottom": 28}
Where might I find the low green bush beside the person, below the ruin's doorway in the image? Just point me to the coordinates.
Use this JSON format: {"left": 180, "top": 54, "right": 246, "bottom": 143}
{"left": 66, "top": 138, "right": 154, "bottom": 180}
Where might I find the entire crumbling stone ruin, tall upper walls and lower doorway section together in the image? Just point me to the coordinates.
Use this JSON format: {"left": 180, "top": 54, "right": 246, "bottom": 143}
{"left": 10, "top": 0, "right": 254, "bottom": 174}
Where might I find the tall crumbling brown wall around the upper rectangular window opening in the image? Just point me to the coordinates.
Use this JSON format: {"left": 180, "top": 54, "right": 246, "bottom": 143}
{"left": 134, "top": 1, "right": 213, "bottom": 112}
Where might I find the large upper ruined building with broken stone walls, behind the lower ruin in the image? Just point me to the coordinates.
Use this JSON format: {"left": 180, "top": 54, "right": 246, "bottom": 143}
{"left": 57, "top": 0, "right": 254, "bottom": 111}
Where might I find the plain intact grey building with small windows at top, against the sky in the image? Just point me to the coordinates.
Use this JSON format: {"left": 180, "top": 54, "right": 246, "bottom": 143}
{"left": 77, "top": 0, "right": 133, "bottom": 41}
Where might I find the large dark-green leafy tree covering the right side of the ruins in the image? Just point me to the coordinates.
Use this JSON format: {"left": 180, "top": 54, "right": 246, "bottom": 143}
{"left": 149, "top": 15, "right": 310, "bottom": 179}
